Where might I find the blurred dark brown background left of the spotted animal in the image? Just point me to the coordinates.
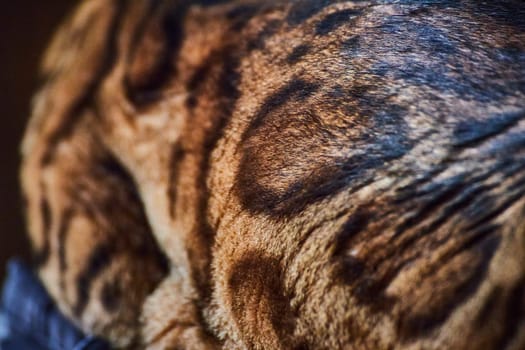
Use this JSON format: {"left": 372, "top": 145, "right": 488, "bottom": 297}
{"left": 0, "top": 0, "right": 75, "bottom": 278}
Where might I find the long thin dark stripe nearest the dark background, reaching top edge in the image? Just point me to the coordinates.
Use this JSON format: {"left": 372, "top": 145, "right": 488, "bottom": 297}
{"left": 41, "top": 0, "right": 127, "bottom": 168}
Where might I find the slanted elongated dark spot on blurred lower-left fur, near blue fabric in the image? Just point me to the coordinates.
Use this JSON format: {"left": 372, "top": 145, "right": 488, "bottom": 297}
{"left": 73, "top": 242, "right": 115, "bottom": 318}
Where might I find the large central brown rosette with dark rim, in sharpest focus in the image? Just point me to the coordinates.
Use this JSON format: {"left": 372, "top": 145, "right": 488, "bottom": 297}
{"left": 235, "top": 78, "right": 416, "bottom": 217}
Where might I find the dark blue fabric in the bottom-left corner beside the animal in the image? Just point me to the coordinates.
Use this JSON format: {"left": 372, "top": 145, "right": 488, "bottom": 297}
{"left": 0, "top": 260, "right": 109, "bottom": 350}
